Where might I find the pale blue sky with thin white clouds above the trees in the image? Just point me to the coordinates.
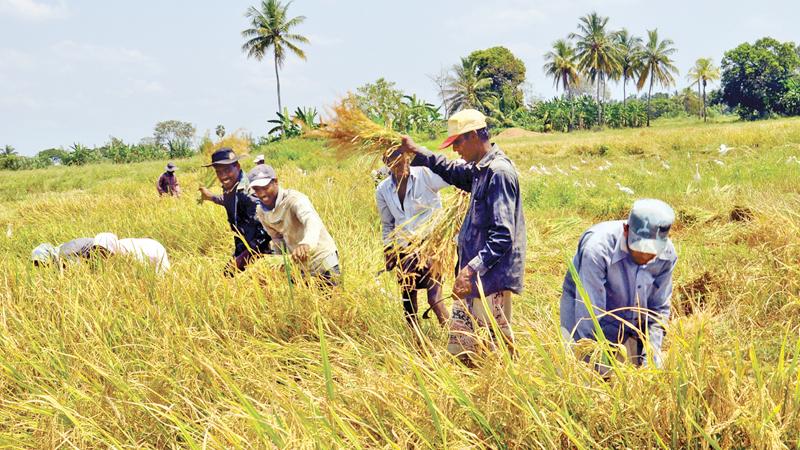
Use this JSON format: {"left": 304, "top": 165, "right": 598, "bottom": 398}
{"left": 0, "top": 0, "right": 800, "bottom": 155}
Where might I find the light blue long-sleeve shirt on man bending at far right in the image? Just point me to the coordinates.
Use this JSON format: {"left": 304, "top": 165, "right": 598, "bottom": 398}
{"left": 560, "top": 220, "right": 678, "bottom": 365}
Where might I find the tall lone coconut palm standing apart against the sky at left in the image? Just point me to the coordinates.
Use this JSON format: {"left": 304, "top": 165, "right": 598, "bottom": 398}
{"left": 242, "top": 0, "right": 308, "bottom": 111}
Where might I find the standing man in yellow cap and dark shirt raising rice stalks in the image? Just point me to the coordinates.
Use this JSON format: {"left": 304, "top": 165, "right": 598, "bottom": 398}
{"left": 400, "top": 109, "right": 526, "bottom": 364}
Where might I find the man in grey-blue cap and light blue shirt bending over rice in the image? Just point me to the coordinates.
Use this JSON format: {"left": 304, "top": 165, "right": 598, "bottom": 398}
{"left": 560, "top": 199, "right": 678, "bottom": 367}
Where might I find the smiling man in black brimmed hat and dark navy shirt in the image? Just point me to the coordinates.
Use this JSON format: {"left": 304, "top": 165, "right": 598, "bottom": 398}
{"left": 200, "top": 148, "right": 271, "bottom": 275}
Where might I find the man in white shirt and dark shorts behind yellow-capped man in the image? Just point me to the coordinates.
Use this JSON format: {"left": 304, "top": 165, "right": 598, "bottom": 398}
{"left": 375, "top": 151, "right": 450, "bottom": 327}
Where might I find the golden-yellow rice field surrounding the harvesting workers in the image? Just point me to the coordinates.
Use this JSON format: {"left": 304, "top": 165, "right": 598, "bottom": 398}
{"left": 0, "top": 119, "right": 800, "bottom": 449}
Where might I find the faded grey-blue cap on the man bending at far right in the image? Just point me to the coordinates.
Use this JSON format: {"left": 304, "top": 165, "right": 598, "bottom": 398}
{"left": 628, "top": 199, "right": 675, "bottom": 255}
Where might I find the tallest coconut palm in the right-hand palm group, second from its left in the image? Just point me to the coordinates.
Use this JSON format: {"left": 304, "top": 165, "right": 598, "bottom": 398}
{"left": 569, "top": 12, "right": 620, "bottom": 124}
